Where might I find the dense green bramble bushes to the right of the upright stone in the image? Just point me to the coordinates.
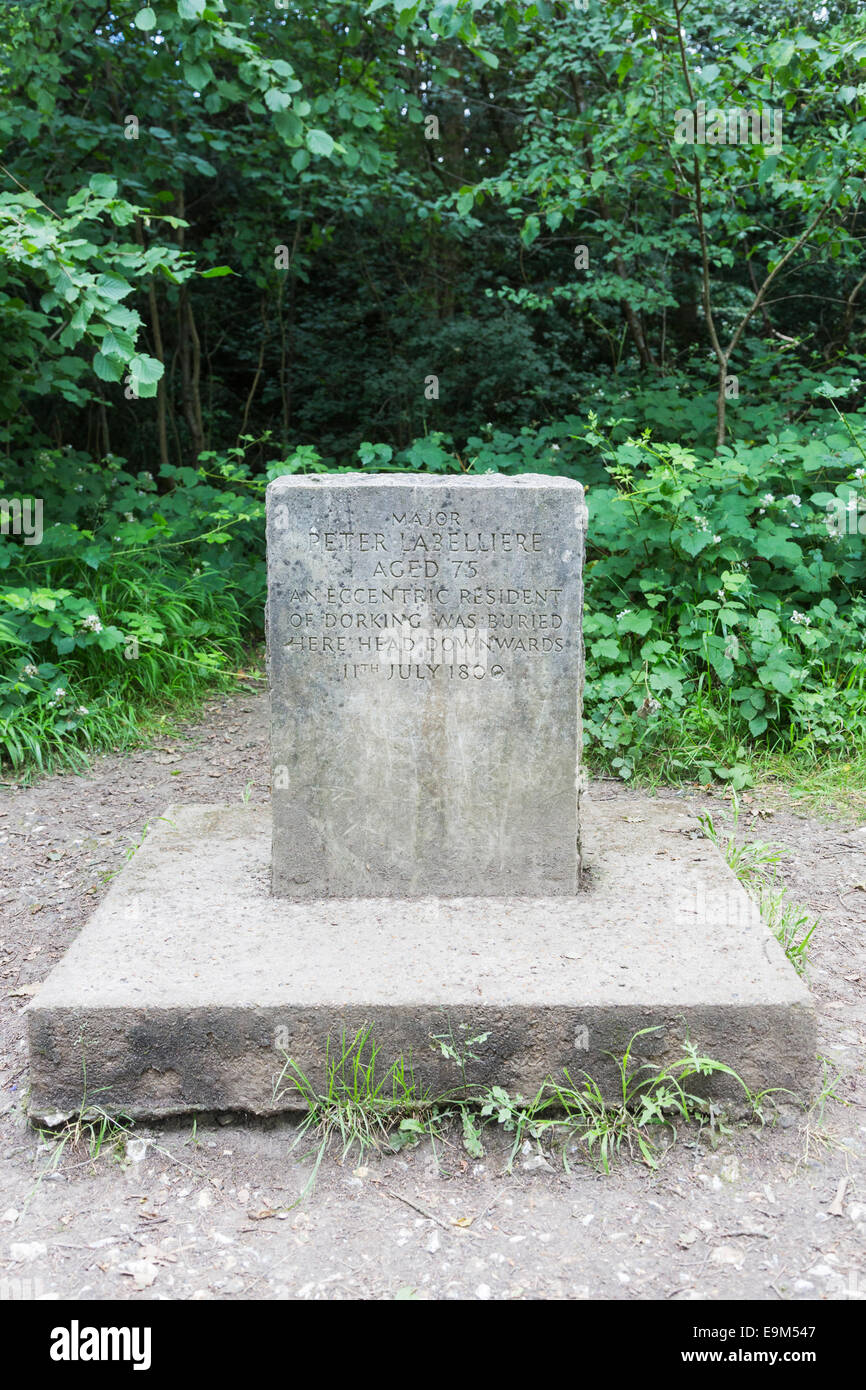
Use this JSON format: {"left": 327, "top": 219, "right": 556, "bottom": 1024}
{"left": 584, "top": 405, "right": 866, "bottom": 785}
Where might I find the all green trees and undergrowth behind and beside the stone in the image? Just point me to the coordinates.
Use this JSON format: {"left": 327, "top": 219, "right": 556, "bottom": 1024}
{"left": 0, "top": 0, "right": 866, "bottom": 785}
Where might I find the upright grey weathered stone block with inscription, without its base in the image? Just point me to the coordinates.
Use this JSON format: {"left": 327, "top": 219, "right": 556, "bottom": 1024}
{"left": 267, "top": 474, "right": 587, "bottom": 899}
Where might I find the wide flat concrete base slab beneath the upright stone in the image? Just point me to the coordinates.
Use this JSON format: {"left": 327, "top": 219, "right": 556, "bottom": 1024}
{"left": 28, "top": 799, "right": 816, "bottom": 1119}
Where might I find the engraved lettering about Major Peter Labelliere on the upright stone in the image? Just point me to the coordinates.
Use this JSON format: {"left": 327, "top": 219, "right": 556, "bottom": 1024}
{"left": 275, "top": 506, "right": 566, "bottom": 681}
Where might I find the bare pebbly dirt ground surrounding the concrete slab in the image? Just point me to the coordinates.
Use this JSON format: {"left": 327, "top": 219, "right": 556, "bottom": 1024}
{"left": 0, "top": 695, "right": 866, "bottom": 1300}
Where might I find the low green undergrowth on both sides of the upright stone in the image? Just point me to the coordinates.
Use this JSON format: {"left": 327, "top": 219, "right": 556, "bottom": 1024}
{"left": 0, "top": 363, "right": 866, "bottom": 787}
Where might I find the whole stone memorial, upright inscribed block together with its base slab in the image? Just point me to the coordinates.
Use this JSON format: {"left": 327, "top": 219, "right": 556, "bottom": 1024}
{"left": 28, "top": 473, "right": 816, "bottom": 1123}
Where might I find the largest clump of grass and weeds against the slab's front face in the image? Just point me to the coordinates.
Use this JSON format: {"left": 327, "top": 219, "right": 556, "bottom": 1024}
{"left": 274, "top": 1022, "right": 773, "bottom": 1197}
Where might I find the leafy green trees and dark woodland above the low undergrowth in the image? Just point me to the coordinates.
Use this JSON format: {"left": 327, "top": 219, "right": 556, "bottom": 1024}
{"left": 6, "top": 0, "right": 866, "bottom": 468}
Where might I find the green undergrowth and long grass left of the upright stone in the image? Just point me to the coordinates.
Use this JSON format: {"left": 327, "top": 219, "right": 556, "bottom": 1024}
{"left": 0, "top": 448, "right": 271, "bottom": 767}
